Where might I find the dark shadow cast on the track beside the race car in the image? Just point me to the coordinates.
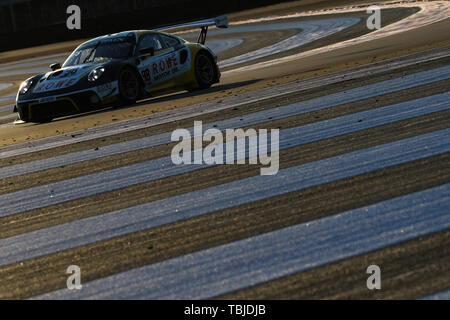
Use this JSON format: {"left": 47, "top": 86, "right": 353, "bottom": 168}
{"left": 45, "top": 80, "right": 259, "bottom": 125}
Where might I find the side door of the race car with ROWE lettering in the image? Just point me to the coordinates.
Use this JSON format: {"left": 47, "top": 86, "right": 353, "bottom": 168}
{"left": 137, "top": 33, "right": 191, "bottom": 91}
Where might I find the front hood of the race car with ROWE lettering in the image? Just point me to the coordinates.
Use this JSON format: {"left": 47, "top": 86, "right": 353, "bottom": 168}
{"left": 33, "top": 63, "right": 105, "bottom": 93}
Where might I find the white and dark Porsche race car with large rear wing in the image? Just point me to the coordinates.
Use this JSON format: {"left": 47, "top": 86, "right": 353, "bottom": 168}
{"left": 15, "top": 16, "right": 228, "bottom": 122}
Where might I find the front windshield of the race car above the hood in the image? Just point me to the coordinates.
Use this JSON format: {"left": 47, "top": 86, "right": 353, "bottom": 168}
{"left": 63, "top": 38, "right": 134, "bottom": 67}
